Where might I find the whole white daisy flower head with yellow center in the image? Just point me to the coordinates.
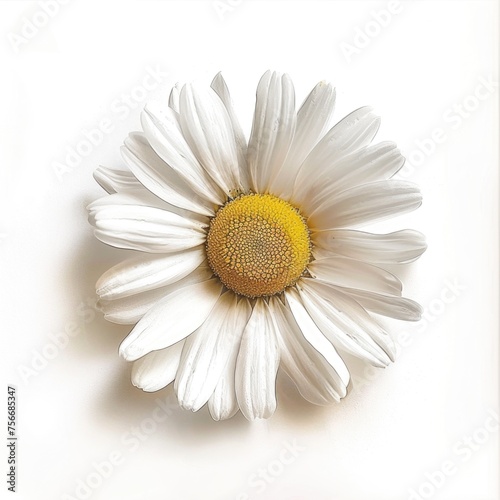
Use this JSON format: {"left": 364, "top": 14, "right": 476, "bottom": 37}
{"left": 89, "top": 71, "right": 426, "bottom": 420}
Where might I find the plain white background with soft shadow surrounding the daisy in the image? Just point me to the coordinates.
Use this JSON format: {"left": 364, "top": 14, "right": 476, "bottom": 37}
{"left": 0, "top": 0, "right": 500, "bottom": 500}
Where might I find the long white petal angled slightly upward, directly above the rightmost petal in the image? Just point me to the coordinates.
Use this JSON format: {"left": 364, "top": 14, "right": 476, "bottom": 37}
{"left": 308, "top": 180, "right": 422, "bottom": 231}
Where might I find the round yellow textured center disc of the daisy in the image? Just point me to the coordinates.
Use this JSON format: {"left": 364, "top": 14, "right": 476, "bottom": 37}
{"left": 207, "top": 194, "right": 311, "bottom": 297}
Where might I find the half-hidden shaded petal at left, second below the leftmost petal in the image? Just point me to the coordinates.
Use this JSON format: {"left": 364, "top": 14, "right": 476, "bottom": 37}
{"left": 98, "top": 266, "right": 213, "bottom": 325}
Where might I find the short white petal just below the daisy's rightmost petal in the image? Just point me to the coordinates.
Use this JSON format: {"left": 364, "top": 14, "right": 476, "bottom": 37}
{"left": 307, "top": 257, "right": 403, "bottom": 296}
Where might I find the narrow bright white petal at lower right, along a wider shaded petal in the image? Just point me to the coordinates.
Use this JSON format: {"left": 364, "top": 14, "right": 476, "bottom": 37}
{"left": 285, "top": 288, "right": 351, "bottom": 398}
